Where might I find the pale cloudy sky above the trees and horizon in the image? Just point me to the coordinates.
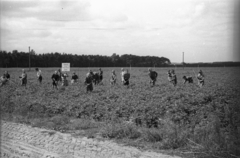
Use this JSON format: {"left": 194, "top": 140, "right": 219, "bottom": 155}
{"left": 0, "top": 0, "right": 240, "bottom": 63}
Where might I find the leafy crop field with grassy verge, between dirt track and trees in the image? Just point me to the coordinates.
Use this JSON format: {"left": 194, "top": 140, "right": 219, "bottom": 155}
{"left": 0, "top": 67, "right": 240, "bottom": 157}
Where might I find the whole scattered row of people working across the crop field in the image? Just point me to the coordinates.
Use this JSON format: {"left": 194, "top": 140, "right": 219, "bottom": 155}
{"left": 0, "top": 68, "right": 204, "bottom": 92}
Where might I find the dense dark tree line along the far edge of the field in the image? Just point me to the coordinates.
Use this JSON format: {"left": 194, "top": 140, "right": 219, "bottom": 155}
{"left": 0, "top": 50, "right": 171, "bottom": 67}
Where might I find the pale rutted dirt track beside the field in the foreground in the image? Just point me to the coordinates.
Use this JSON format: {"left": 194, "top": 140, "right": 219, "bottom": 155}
{"left": 1, "top": 121, "right": 182, "bottom": 158}
